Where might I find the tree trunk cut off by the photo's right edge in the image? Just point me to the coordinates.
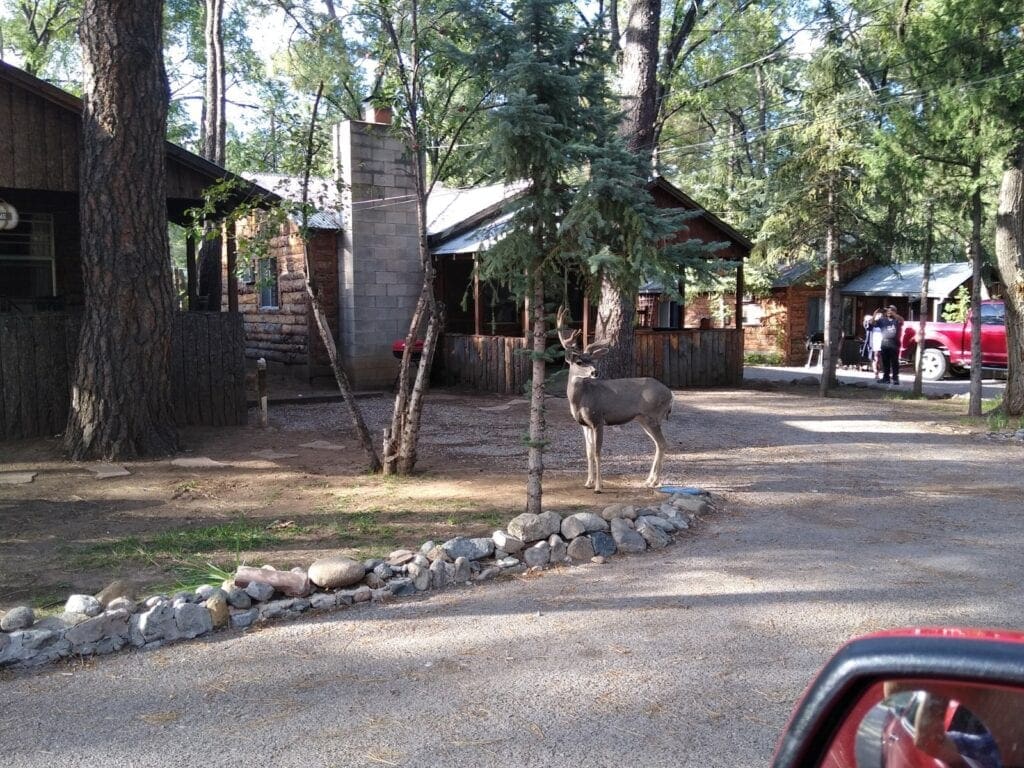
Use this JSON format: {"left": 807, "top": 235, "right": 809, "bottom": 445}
{"left": 995, "top": 143, "right": 1024, "bottom": 416}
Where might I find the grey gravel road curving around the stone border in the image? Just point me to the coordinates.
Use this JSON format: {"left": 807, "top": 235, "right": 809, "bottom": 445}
{"left": 0, "top": 391, "right": 1024, "bottom": 768}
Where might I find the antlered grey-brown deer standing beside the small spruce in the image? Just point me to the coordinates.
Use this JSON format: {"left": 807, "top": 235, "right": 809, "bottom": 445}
{"left": 555, "top": 306, "right": 672, "bottom": 494}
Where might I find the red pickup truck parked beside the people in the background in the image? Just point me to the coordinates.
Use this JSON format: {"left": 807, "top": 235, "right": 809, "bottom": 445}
{"left": 900, "top": 301, "right": 1008, "bottom": 381}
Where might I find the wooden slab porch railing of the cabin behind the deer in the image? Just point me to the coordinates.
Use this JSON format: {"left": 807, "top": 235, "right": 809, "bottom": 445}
{"left": 444, "top": 329, "right": 743, "bottom": 394}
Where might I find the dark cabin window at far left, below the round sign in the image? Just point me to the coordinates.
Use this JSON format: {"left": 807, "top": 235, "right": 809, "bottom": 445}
{"left": 0, "top": 213, "right": 56, "bottom": 311}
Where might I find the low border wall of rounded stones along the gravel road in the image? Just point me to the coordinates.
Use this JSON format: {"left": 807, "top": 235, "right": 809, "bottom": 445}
{"left": 0, "top": 493, "right": 714, "bottom": 668}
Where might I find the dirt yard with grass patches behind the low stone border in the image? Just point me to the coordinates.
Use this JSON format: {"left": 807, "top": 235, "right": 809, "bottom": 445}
{"left": 0, "top": 385, "right": 967, "bottom": 610}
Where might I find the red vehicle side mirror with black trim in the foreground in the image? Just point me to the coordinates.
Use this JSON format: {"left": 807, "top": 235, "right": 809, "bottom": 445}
{"left": 772, "top": 630, "right": 1024, "bottom": 768}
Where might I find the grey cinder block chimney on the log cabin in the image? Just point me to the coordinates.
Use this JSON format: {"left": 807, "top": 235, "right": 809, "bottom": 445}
{"left": 334, "top": 119, "right": 422, "bottom": 389}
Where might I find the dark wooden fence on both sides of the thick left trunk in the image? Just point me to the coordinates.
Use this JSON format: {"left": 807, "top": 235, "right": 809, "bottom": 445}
{"left": 0, "top": 312, "right": 246, "bottom": 439}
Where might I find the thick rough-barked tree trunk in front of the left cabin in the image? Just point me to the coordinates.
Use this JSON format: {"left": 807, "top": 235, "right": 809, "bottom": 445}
{"left": 65, "top": 0, "right": 177, "bottom": 460}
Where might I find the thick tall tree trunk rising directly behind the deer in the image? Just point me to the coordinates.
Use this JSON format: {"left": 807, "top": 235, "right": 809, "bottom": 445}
{"left": 595, "top": 0, "right": 662, "bottom": 378}
